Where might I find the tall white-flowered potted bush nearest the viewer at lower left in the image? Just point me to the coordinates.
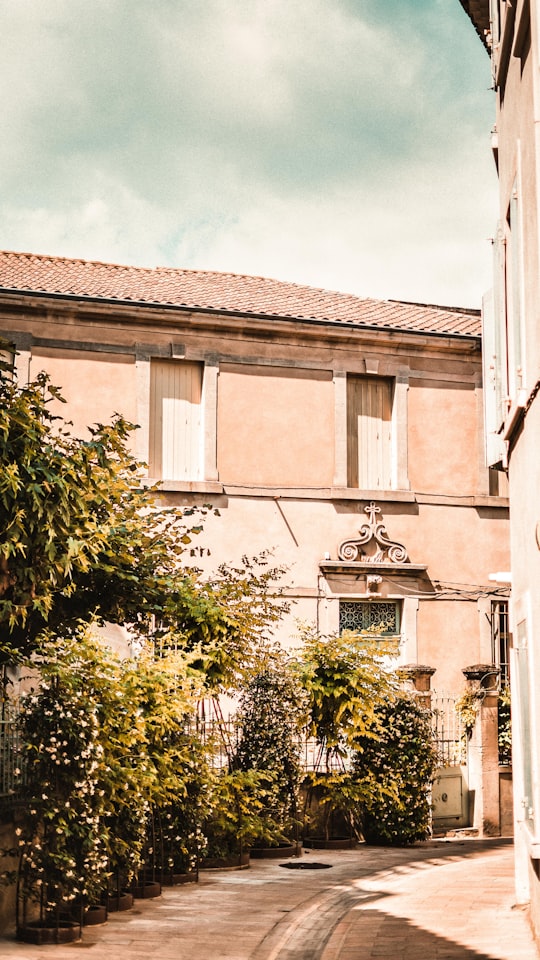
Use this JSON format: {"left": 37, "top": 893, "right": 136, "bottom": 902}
{"left": 17, "top": 638, "right": 113, "bottom": 913}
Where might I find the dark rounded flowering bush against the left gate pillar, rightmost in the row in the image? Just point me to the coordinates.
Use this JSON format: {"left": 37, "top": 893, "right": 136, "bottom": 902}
{"left": 354, "top": 694, "right": 437, "bottom": 845}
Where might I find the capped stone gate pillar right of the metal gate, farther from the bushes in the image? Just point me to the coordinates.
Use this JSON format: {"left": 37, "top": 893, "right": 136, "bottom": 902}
{"left": 463, "top": 663, "right": 501, "bottom": 837}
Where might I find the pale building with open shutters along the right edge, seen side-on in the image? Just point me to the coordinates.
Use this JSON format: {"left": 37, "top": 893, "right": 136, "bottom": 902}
{"left": 462, "top": 0, "right": 540, "bottom": 936}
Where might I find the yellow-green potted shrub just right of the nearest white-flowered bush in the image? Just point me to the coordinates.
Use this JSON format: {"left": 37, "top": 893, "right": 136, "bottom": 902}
{"left": 107, "top": 650, "right": 204, "bottom": 898}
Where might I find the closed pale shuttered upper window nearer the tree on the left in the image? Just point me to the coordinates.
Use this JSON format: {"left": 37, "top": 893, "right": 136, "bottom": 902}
{"left": 148, "top": 360, "right": 203, "bottom": 480}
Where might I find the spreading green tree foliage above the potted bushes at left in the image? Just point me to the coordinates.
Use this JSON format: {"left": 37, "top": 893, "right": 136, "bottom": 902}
{"left": 0, "top": 371, "right": 283, "bottom": 686}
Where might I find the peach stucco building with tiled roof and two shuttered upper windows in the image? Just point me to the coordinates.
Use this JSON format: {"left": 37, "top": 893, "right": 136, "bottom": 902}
{"left": 0, "top": 253, "right": 508, "bottom": 712}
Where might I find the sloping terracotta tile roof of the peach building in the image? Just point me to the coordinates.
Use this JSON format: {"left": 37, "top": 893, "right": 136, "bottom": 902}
{"left": 0, "top": 251, "right": 480, "bottom": 337}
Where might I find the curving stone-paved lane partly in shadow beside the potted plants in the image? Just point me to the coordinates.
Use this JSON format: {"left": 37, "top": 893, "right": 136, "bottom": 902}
{"left": 0, "top": 839, "right": 540, "bottom": 960}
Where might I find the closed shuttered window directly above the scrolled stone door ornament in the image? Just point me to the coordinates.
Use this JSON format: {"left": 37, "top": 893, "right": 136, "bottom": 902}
{"left": 347, "top": 376, "right": 395, "bottom": 490}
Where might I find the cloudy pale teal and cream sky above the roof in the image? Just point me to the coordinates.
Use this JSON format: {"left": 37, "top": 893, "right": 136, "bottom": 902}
{"left": 0, "top": 0, "right": 496, "bottom": 307}
